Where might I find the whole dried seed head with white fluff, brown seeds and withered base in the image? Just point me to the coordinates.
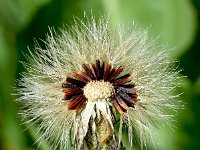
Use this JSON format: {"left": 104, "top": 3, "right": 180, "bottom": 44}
{"left": 18, "top": 15, "right": 178, "bottom": 149}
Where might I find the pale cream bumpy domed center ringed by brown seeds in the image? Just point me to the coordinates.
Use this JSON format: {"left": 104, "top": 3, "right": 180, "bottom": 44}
{"left": 83, "top": 81, "right": 114, "bottom": 101}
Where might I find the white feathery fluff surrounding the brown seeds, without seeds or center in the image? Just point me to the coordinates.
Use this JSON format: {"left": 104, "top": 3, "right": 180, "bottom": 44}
{"left": 18, "top": 15, "right": 178, "bottom": 149}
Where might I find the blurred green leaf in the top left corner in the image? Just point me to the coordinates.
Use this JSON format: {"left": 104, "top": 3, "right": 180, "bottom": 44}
{"left": 0, "top": 0, "right": 51, "bottom": 29}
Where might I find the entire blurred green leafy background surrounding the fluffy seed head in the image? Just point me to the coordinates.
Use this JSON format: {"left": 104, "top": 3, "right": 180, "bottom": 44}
{"left": 0, "top": 0, "right": 200, "bottom": 150}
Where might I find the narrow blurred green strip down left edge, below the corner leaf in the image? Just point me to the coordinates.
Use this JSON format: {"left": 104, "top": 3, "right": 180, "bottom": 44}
{"left": 0, "top": 26, "right": 25, "bottom": 150}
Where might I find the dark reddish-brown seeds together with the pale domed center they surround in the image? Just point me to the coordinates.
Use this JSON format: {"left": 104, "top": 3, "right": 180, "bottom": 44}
{"left": 62, "top": 60, "right": 137, "bottom": 113}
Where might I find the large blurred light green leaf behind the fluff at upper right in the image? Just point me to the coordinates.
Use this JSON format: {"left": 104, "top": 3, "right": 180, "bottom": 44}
{"left": 82, "top": 0, "right": 196, "bottom": 58}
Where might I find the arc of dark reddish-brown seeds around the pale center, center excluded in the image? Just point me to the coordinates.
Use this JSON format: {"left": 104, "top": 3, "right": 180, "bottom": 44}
{"left": 62, "top": 60, "right": 138, "bottom": 113}
